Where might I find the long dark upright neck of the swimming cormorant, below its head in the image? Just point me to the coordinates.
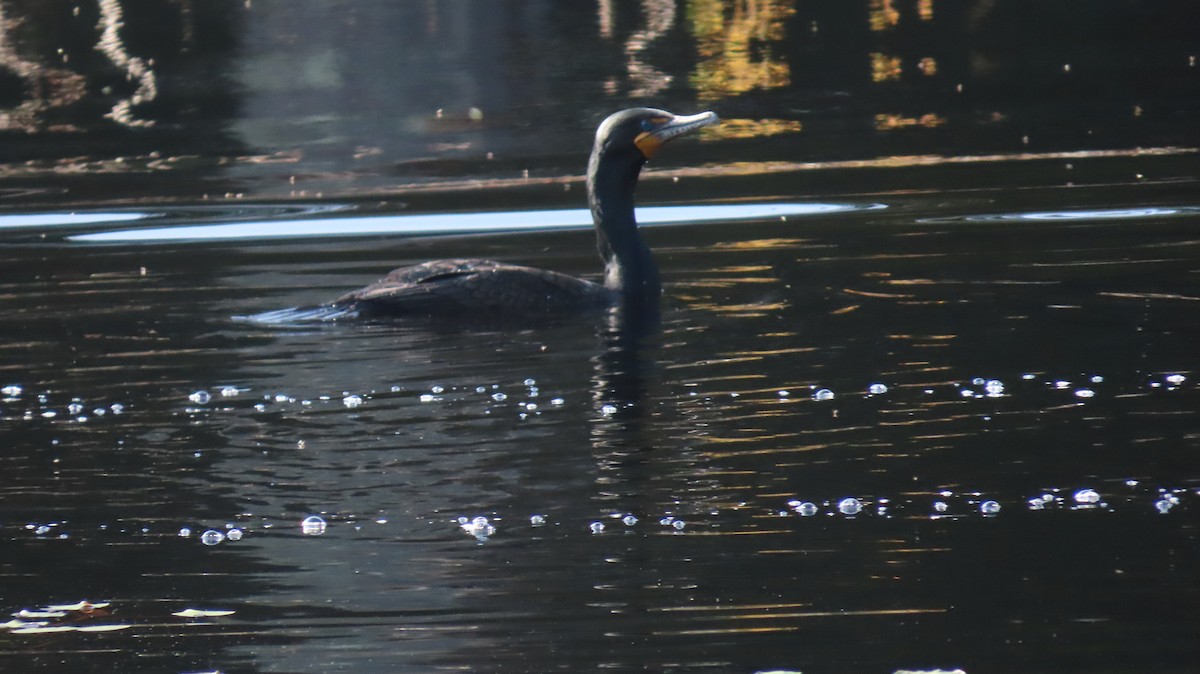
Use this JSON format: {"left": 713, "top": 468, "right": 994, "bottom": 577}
{"left": 588, "top": 151, "right": 661, "bottom": 302}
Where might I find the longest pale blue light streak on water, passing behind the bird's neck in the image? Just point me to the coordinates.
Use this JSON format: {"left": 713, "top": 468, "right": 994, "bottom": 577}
{"left": 67, "top": 204, "right": 873, "bottom": 243}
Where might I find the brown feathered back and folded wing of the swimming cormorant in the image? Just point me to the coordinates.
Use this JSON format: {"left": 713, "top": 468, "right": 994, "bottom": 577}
{"left": 334, "top": 259, "right": 610, "bottom": 313}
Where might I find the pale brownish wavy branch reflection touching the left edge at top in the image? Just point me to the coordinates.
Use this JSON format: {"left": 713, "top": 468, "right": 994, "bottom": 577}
{"left": 0, "top": 4, "right": 85, "bottom": 133}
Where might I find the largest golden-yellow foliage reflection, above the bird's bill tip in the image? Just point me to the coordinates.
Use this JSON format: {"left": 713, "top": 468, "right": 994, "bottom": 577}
{"left": 688, "top": 0, "right": 794, "bottom": 101}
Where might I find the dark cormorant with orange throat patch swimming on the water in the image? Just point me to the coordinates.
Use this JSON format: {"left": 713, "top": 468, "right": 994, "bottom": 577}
{"left": 302, "top": 108, "right": 718, "bottom": 319}
